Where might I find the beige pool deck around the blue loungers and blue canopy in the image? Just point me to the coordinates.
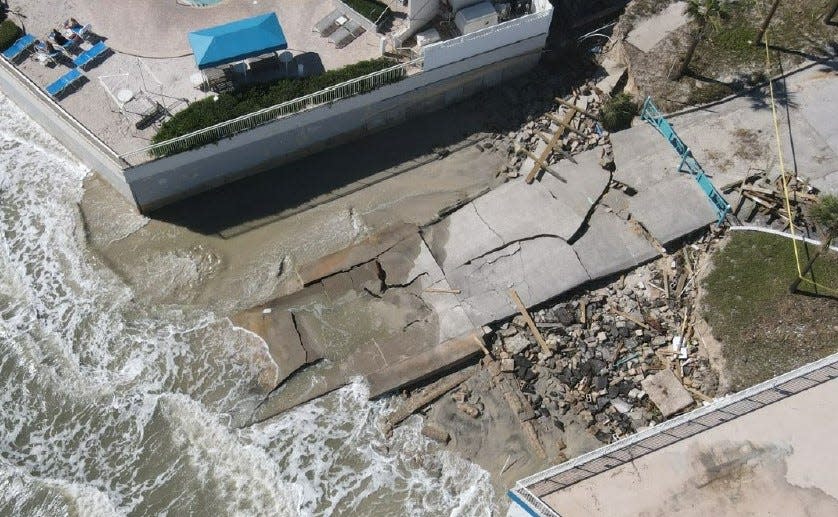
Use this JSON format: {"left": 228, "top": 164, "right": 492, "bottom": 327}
{"left": 10, "top": 0, "right": 380, "bottom": 154}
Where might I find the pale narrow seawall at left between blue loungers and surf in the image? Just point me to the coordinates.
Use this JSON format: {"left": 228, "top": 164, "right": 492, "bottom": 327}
{"left": 0, "top": 58, "right": 134, "bottom": 202}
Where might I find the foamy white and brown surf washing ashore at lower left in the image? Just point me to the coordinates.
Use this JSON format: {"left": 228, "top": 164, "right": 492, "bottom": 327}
{"left": 0, "top": 96, "right": 497, "bottom": 515}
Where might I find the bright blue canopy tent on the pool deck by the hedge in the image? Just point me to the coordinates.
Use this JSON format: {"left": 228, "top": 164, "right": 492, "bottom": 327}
{"left": 189, "top": 13, "right": 288, "bottom": 70}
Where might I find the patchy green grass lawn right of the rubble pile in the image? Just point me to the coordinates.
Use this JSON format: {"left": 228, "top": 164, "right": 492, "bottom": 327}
{"left": 702, "top": 232, "right": 838, "bottom": 390}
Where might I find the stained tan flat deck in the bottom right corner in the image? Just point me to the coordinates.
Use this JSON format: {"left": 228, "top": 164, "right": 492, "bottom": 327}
{"left": 543, "top": 366, "right": 838, "bottom": 517}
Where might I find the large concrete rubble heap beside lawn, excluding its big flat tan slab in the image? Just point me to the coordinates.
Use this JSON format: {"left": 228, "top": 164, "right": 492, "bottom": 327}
{"left": 493, "top": 234, "right": 718, "bottom": 443}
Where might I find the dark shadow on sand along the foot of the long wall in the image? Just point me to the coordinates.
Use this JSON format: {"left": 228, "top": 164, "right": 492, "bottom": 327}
{"left": 149, "top": 64, "right": 576, "bottom": 236}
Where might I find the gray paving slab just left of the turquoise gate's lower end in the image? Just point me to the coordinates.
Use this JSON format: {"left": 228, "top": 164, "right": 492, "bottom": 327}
{"left": 629, "top": 174, "right": 716, "bottom": 245}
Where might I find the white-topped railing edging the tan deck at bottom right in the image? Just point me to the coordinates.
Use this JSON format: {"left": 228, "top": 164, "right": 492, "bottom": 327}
{"left": 510, "top": 348, "right": 838, "bottom": 517}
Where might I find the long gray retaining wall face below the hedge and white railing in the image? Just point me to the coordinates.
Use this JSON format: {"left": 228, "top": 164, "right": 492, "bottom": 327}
{"left": 125, "top": 33, "right": 549, "bottom": 210}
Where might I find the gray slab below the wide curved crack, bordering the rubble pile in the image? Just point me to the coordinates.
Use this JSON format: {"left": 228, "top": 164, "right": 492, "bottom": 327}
{"left": 573, "top": 207, "right": 658, "bottom": 278}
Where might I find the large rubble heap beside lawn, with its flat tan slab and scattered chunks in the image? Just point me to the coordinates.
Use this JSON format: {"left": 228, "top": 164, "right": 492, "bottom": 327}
{"left": 410, "top": 232, "right": 720, "bottom": 460}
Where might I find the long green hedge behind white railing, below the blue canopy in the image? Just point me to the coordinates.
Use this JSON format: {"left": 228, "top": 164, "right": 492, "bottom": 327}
{"left": 152, "top": 58, "right": 398, "bottom": 147}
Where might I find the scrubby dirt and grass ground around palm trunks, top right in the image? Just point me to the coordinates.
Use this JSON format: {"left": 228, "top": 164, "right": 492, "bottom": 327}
{"left": 614, "top": 0, "right": 838, "bottom": 111}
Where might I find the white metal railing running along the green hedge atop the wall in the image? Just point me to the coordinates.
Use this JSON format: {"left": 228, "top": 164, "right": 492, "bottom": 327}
{"left": 120, "top": 58, "right": 422, "bottom": 165}
